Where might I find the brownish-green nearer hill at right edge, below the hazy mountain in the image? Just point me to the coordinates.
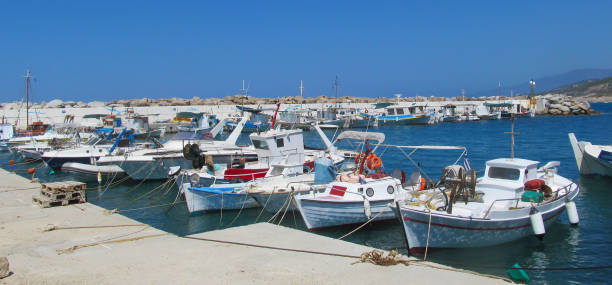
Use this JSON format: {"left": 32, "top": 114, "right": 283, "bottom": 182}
{"left": 543, "top": 77, "right": 612, "bottom": 102}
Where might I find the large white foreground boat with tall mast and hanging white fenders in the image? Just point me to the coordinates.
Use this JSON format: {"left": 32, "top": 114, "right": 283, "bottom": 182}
{"left": 396, "top": 120, "right": 579, "bottom": 254}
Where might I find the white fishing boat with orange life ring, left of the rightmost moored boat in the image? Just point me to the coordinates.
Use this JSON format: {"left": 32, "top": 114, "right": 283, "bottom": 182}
{"left": 294, "top": 133, "right": 420, "bottom": 230}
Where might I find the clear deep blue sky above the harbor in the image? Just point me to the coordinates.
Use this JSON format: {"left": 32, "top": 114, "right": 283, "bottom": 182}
{"left": 0, "top": 1, "right": 612, "bottom": 102}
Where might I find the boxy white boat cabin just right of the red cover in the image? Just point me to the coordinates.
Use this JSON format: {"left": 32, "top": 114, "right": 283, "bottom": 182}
{"left": 250, "top": 130, "right": 305, "bottom": 175}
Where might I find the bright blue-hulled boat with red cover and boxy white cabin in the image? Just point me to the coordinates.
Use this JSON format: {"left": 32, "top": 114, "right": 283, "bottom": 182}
{"left": 179, "top": 121, "right": 316, "bottom": 213}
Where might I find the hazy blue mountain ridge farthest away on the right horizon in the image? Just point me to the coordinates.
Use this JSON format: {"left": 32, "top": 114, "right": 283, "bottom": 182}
{"left": 472, "top": 69, "right": 612, "bottom": 97}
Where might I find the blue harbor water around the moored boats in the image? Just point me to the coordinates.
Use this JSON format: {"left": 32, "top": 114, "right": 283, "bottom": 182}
{"left": 0, "top": 104, "right": 612, "bottom": 284}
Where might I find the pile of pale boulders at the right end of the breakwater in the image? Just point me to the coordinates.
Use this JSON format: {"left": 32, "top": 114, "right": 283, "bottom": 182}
{"left": 536, "top": 94, "right": 598, "bottom": 116}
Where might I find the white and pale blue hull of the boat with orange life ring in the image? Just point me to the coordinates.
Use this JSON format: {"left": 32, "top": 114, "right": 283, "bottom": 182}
{"left": 295, "top": 197, "right": 395, "bottom": 231}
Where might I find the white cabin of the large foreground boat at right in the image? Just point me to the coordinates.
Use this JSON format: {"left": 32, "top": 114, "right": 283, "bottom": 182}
{"left": 476, "top": 158, "right": 539, "bottom": 199}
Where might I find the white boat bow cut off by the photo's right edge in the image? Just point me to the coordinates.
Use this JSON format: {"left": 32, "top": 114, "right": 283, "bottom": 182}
{"left": 568, "top": 133, "right": 612, "bottom": 177}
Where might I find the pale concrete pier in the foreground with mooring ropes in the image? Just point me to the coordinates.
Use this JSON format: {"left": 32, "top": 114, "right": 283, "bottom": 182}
{"left": 0, "top": 169, "right": 506, "bottom": 284}
